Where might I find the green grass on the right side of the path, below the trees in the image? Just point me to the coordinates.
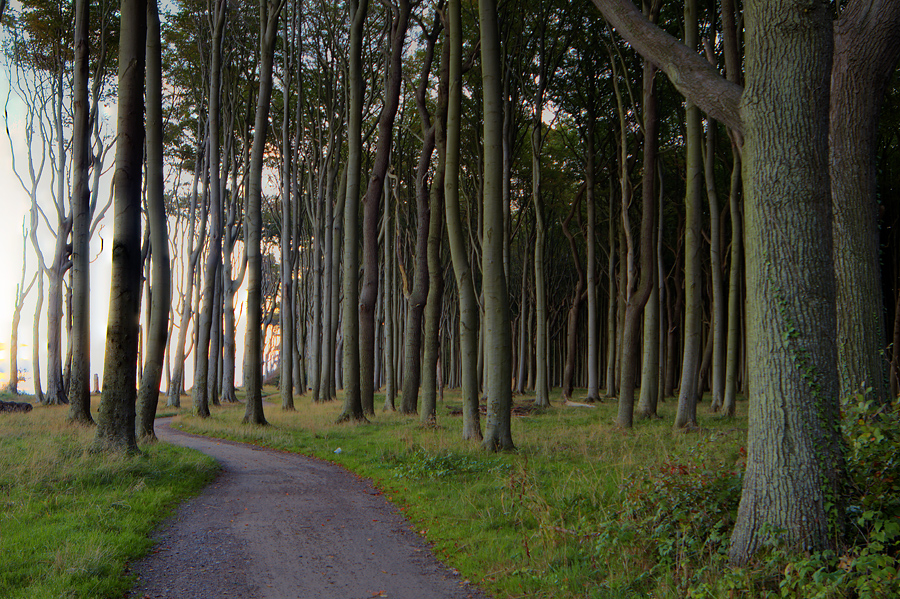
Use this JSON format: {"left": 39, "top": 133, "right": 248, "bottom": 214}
{"left": 176, "top": 389, "right": 746, "bottom": 599}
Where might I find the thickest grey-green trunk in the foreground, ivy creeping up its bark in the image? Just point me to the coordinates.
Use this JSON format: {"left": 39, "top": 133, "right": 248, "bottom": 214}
{"left": 729, "top": 0, "right": 844, "bottom": 564}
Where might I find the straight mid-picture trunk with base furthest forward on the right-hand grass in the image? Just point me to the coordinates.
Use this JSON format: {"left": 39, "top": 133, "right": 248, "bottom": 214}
{"left": 478, "top": 0, "right": 514, "bottom": 451}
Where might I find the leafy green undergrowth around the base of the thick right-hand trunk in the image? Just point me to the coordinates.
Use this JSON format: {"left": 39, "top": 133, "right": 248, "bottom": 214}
{"left": 595, "top": 395, "right": 900, "bottom": 599}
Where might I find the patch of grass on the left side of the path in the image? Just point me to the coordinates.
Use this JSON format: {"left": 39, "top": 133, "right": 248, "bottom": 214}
{"left": 0, "top": 396, "right": 218, "bottom": 599}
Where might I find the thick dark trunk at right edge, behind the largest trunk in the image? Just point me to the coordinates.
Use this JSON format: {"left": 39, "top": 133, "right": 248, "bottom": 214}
{"left": 828, "top": 1, "right": 900, "bottom": 402}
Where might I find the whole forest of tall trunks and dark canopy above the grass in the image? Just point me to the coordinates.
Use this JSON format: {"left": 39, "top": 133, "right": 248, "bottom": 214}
{"left": 2, "top": 0, "right": 900, "bottom": 596}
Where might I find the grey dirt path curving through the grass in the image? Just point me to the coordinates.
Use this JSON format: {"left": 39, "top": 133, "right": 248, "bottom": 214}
{"left": 130, "top": 420, "right": 487, "bottom": 599}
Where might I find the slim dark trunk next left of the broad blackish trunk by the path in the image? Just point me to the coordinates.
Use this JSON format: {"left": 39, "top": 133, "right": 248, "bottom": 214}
{"left": 67, "top": 0, "right": 94, "bottom": 423}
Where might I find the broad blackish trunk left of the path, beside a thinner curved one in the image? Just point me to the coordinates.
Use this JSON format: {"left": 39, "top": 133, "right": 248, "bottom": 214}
{"left": 92, "top": 0, "right": 147, "bottom": 453}
